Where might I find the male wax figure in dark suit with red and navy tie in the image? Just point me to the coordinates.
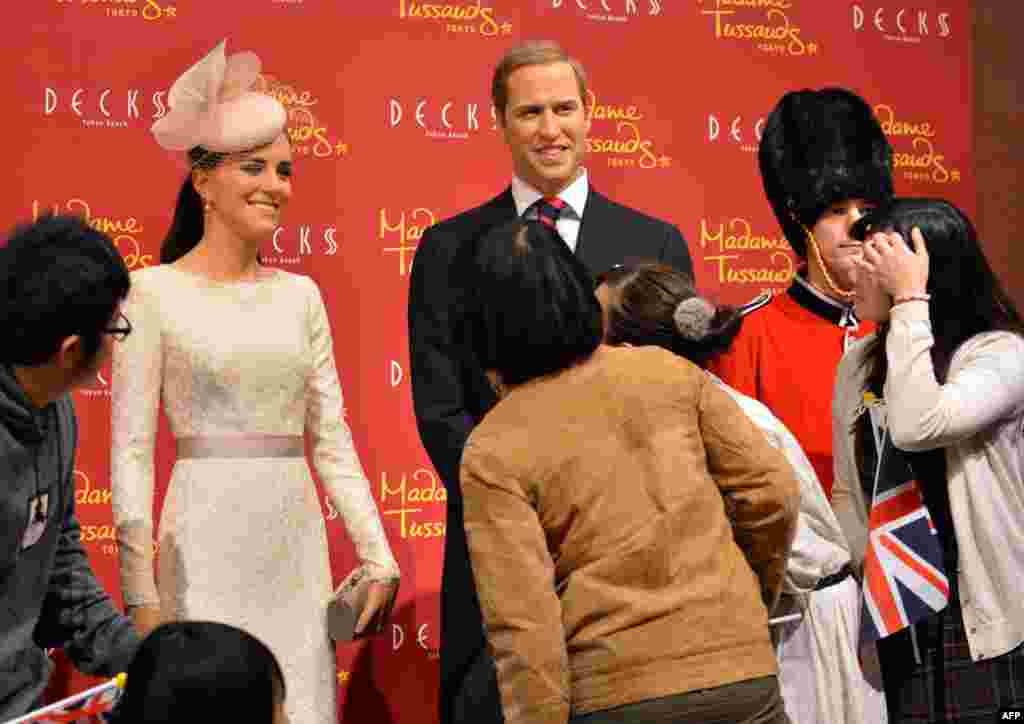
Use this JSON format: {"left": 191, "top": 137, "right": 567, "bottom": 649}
{"left": 409, "top": 42, "right": 692, "bottom": 724}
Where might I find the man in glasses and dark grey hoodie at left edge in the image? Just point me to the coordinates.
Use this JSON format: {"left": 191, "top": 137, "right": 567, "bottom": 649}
{"left": 0, "top": 216, "right": 139, "bottom": 721}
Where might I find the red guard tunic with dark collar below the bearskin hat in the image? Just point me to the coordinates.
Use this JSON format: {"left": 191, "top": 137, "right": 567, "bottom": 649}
{"left": 709, "top": 276, "right": 874, "bottom": 500}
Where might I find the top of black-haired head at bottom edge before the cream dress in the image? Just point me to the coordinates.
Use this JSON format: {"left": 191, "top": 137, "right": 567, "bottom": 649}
{"left": 111, "top": 621, "right": 288, "bottom": 724}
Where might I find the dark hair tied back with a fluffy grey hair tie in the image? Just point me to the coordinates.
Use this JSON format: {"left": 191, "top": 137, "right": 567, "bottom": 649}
{"left": 602, "top": 263, "right": 743, "bottom": 367}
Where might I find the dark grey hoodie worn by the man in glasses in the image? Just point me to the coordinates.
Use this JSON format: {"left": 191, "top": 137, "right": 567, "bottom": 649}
{"left": 0, "top": 365, "right": 138, "bottom": 721}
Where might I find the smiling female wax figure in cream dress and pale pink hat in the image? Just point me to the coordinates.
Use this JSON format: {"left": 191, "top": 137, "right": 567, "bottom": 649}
{"left": 112, "top": 43, "right": 398, "bottom": 724}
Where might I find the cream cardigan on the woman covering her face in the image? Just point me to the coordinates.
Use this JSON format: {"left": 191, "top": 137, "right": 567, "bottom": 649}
{"left": 833, "top": 302, "right": 1024, "bottom": 661}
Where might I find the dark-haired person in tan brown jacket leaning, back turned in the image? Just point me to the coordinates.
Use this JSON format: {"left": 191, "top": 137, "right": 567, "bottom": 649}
{"left": 458, "top": 221, "right": 798, "bottom": 724}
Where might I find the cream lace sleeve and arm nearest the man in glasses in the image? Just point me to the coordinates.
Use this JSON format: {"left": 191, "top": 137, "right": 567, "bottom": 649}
{"left": 111, "top": 273, "right": 163, "bottom": 606}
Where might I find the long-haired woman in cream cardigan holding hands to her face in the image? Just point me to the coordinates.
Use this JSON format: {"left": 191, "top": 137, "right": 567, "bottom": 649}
{"left": 833, "top": 199, "right": 1024, "bottom": 723}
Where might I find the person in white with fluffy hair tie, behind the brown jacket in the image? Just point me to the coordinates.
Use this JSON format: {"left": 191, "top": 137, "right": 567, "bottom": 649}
{"left": 597, "top": 263, "right": 886, "bottom": 724}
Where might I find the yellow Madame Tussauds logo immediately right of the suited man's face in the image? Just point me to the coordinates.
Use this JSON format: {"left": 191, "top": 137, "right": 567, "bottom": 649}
{"left": 587, "top": 90, "right": 672, "bottom": 169}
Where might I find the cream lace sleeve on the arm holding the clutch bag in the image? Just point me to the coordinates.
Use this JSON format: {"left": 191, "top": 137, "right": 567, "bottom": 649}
{"left": 306, "top": 280, "right": 398, "bottom": 581}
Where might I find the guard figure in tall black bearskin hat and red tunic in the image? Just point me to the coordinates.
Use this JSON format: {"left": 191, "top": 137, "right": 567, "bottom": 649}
{"left": 709, "top": 88, "right": 893, "bottom": 500}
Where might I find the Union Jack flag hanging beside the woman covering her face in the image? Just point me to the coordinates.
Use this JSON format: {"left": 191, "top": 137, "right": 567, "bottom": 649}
{"left": 861, "top": 411, "right": 949, "bottom": 642}
